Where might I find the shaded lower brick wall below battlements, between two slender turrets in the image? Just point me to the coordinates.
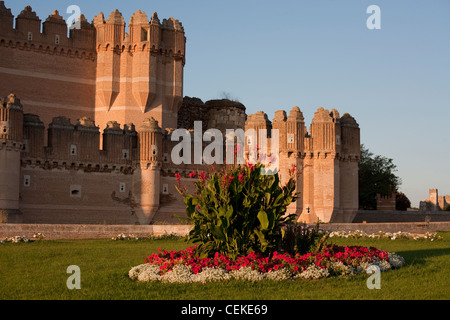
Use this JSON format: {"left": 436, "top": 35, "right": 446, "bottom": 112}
{"left": 20, "top": 166, "right": 134, "bottom": 224}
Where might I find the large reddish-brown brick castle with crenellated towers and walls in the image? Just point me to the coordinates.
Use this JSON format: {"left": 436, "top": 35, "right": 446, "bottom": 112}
{"left": 0, "top": 1, "right": 360, "bottom": 224}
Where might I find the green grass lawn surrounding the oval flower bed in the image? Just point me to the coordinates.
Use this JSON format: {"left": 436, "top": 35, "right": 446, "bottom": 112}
{"left": 0, "top": 232, "right": 450, "bottom": 300}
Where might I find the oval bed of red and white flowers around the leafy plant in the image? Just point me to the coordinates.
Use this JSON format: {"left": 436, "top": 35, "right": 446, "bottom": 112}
{"left": 129, "top": 245, "right": 404, "bottom": 283}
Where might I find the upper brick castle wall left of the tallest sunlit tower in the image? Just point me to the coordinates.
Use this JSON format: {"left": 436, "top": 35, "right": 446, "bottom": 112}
{"left": 0, "top": 6, "right": 96, "bottom": 137}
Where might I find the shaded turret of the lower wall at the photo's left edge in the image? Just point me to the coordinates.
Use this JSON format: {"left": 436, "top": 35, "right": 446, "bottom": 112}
{"left": 0, "top": 94, "right": 23, "bottom": 223}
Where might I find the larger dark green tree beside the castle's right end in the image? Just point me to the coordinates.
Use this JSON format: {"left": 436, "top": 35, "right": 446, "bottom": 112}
{"left": 359, "top": 144, "right": 401, "bottom": 210}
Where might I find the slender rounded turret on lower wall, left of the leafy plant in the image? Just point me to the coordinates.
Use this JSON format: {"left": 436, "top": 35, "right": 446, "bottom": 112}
{"left": 133, "top": 118, "right": 163, "bottom": 224}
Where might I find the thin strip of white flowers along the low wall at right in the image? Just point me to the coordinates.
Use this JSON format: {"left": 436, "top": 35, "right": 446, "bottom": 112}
{"left": 330, "top": 230, "right": 442, "bottom": 241}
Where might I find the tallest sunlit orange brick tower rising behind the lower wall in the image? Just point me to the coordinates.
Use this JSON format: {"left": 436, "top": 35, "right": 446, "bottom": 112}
{"left": 94, "top": 10, "right": 186, "bottom": 134}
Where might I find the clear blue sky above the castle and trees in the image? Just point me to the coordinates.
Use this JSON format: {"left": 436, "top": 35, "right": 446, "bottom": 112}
{"left": 6, "top": 0, "right": 450, "bottom": 206}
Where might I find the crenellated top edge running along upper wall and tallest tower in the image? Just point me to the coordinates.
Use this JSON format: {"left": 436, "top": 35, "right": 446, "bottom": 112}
{"left": 0, "top": 1, "right": 186, "bottom": 63}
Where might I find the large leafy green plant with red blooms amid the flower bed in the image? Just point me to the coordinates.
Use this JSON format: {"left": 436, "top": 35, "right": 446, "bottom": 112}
{"left": 178, "top": 163, "right": 297, "bottom": 257}
